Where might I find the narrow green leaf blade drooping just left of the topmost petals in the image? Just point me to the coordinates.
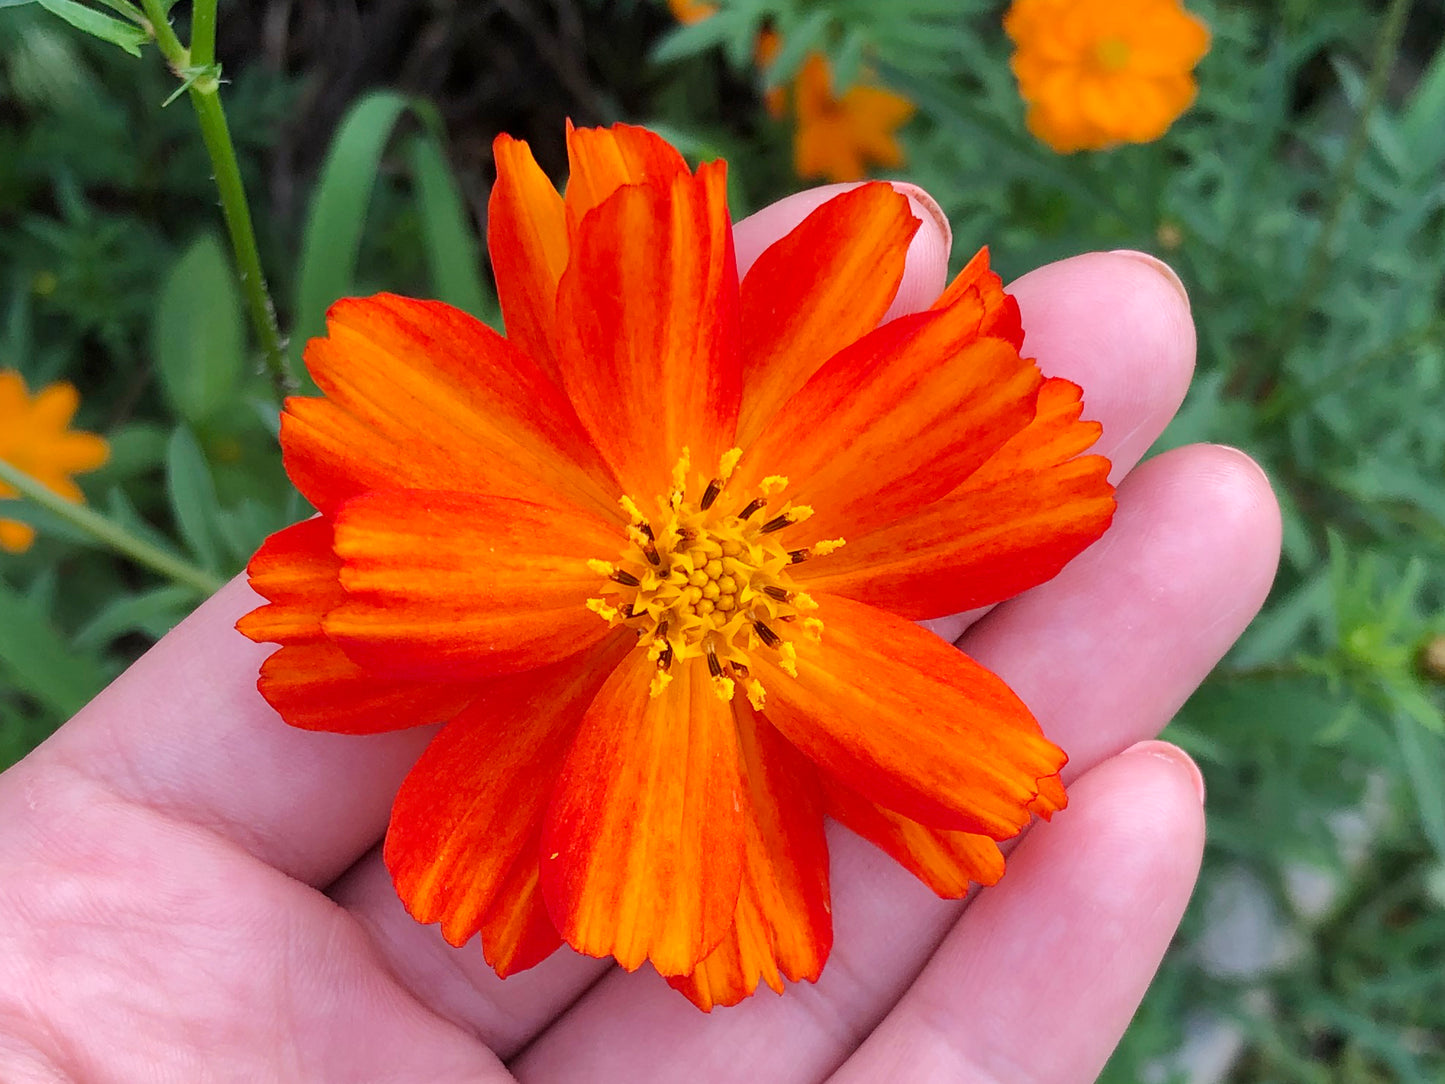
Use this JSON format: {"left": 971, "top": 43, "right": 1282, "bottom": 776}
{"left": 407, "top": 132, "right": 491, "bottom": 318}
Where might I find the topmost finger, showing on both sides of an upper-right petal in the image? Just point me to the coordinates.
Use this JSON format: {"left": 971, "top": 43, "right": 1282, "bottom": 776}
{"left": 733, "top": 181, "right": 954, "bottom": 319}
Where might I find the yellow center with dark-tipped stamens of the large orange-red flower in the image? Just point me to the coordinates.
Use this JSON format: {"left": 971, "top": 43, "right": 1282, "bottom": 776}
{"left": 587, "top": 448, "right": 842, "bottom": 708}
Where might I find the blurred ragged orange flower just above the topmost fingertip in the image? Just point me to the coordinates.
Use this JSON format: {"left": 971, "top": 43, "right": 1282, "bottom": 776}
{"left": 793, "top": 52, "right": 913, "bottom": 181}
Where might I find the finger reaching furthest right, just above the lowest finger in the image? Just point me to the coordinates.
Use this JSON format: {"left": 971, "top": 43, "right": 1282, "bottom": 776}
{"left": 513, "top": 447, "right": 1279, "bottom": 1081}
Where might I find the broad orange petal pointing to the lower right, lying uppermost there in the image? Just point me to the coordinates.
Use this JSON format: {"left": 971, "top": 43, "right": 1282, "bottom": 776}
{"left": 753, "top": 595, "right": 1066, "bottom": 840}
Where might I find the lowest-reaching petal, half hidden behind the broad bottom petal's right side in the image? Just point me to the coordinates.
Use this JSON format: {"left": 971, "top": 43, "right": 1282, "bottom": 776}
{"left": 668, "top": 698, "right": 832, "bottom": 1012}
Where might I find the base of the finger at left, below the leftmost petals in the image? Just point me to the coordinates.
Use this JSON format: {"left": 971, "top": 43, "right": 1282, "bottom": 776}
{"left": 0, "top": 578, "right": 435, "bottom": 885}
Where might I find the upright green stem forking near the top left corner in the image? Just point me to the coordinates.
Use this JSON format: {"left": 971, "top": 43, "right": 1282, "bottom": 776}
{"left": 142, "top": 0, "right": 295, "bottom": 399}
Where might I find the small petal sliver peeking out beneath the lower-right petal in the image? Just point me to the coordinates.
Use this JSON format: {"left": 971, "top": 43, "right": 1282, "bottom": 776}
{"left": 824, "top": 776, "right": 1005, "bottom": 899}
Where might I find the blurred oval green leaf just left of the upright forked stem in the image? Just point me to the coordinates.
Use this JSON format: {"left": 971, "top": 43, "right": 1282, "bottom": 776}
{"left": 152, "top": 234, "right": 246, "bottom": 422}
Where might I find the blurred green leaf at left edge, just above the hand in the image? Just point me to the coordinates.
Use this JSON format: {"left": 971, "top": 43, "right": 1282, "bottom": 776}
{"left": 0, "top": 581, "right": 111, "bottom": 718}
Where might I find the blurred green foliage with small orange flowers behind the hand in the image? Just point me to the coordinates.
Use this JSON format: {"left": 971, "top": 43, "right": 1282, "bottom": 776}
{"left": 0, "top": 0, "right": 1445, "bottom": 1084}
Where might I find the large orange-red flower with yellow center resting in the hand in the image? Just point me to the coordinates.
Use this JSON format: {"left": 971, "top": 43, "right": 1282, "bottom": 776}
{"left": 240, "top": 126, "right": 1113, "bottom": 1009}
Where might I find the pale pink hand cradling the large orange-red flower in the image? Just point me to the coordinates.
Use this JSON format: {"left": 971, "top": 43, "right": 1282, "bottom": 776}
{"left": 0, "top": 189, "right": 1279, "bottom": 1084}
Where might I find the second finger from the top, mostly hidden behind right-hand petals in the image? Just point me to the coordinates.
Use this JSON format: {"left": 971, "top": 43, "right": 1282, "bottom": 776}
{"left": 923, "top": 253, "right": 1195, "bottom": 650}
